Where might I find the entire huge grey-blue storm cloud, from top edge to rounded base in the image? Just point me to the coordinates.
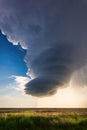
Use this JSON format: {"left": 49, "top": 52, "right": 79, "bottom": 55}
{"left": 0, "top": 0, "right": 87, "bottom": 96}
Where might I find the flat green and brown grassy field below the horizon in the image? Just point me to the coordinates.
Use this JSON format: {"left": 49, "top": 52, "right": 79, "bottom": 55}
{"left": 0, "top": 108, "right": 87, "bottom": 130}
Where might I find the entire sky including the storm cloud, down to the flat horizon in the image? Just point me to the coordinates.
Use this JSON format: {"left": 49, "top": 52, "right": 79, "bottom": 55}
{"left": 0, "top": 0, "right": 87, "bottom": 108}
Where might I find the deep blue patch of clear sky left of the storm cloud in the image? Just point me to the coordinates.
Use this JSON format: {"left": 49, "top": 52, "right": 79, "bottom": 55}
{"left": 0, "top": 32, "right": 27, "bottom": 86}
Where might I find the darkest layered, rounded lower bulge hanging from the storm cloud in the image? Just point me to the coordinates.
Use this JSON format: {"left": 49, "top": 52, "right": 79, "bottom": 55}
{"left": 25, "top": 43, "right": 85, "bottom": 96}
